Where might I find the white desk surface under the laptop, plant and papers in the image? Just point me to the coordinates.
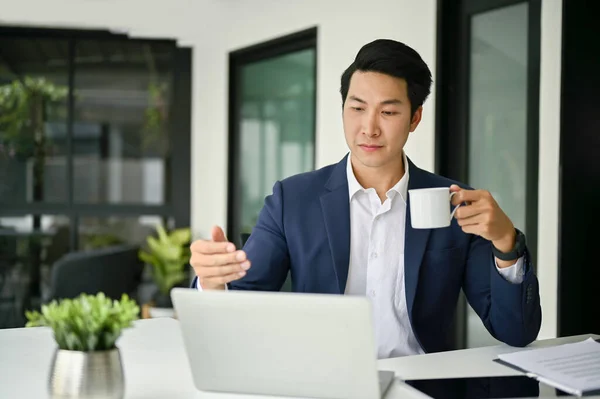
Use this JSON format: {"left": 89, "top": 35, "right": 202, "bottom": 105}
{"left": 0, "top": 319, "right": 597, "bottom": 399}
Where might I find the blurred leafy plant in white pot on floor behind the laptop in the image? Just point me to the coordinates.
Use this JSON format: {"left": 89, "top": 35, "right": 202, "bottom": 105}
{"left": 139, "top": 224, "right": 192, "bottom": 317}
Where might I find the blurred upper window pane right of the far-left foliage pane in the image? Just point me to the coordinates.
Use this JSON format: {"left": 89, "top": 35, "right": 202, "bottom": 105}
{"left": 71, "top": 39, "right": 174, "bottom": 205}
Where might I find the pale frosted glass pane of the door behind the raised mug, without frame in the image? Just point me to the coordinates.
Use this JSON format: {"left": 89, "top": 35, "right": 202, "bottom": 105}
{"left": 467, "top": 2, "right": 536, "bottom": 347}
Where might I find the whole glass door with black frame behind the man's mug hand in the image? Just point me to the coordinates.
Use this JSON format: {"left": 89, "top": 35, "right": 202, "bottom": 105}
{"left": 436, "top": 0, "right": 540, "bottom": 347}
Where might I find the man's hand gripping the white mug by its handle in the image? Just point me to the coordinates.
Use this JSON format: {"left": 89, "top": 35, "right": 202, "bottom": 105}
{"left": 450, "top": 184, "right": 517, "bottom": 267}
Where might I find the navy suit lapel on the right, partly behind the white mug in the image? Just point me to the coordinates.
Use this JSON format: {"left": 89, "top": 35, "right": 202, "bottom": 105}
{"left": 404, "top": 159, "right": 431, "bottom": 315}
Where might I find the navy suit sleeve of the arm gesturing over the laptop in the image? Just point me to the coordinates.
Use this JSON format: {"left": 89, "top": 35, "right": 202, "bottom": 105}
{"left": 228, "top": 182, "right": 290, "bottom": 291}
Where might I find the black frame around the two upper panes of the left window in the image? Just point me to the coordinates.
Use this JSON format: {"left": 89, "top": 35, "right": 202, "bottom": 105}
{"left": 0, "top": 27, "right": 192, "bottom": 251}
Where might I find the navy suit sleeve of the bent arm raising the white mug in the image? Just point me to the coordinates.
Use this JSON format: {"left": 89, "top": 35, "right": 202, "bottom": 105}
{"left": 463, "top": 236, "right": 542, "bottom": 347}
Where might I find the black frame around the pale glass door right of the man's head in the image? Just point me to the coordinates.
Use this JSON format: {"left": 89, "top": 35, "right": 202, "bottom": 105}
{"left": 435, "top": 0, "right": 541, "bottom": 349}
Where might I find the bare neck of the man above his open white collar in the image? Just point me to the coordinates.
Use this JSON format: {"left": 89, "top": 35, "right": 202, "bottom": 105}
{"left": 350, "top": 155, "right": 404, "bottom": 202}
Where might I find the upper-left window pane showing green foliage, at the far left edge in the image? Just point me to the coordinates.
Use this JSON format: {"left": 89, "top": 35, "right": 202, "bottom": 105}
{"left": 0, "top": 36, "right": 69, "bottom": 204}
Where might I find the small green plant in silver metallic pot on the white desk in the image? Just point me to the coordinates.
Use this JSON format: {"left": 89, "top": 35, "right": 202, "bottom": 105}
{"left": 25, "top": 293, "right": 139, "bottom": 399}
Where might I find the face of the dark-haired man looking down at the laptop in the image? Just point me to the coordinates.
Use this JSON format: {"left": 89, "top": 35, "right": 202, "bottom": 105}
{"left": 343, "top": 71, "right": 423, "bottom": 168}
